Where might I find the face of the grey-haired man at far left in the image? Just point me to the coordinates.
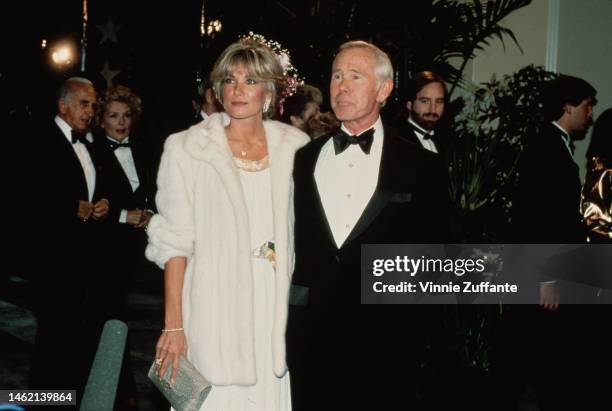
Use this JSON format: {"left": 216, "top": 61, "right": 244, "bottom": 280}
{"left": 58, "top": 84, "right": 96, "bottom": 133}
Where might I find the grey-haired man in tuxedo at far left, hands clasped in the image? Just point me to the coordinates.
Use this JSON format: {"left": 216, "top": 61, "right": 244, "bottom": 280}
{"left": 25, "top": 77, "right": 109, "bottom": 398}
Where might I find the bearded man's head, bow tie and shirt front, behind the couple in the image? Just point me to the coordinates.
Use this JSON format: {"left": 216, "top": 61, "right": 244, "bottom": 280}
{"left": 405, "top": 71, "right": 446, "bottom": 153}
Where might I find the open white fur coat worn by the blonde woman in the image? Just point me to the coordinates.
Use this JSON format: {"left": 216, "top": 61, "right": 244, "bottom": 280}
{"left": 146, "top": 114, "right": 308, "bottom": 385}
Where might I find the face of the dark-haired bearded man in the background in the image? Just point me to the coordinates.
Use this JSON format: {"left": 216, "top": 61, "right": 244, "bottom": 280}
{"left": 406, "top": 82, "right": 444, "bottom": 131}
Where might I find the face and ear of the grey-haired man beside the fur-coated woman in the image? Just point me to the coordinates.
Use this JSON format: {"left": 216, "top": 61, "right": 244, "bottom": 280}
{"left": 329, "top": 48, "right": 393, "bottom": 133}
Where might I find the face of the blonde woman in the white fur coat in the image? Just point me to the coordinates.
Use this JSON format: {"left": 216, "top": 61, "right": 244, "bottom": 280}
{"left": 223, "top": 64, "right": 271, "bottom": 119}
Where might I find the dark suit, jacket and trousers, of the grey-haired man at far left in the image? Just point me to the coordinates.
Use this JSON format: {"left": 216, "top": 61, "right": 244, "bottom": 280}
{"left": 23, "top": 120, "right": 112, "bottom": 396}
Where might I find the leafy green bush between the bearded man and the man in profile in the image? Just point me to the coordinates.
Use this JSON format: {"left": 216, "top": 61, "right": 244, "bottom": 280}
{"left": 448, "top": 65, "right": 555, "bottom": 243}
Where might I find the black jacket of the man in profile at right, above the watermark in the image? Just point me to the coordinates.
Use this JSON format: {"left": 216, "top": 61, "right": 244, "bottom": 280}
{"left": 512, "top": 124, "right": 586, "bottom": 244}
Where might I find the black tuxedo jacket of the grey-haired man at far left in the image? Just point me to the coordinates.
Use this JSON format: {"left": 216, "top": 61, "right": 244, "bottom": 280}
{"left": 25, "top": 121, "right": 113, "bottom": 276}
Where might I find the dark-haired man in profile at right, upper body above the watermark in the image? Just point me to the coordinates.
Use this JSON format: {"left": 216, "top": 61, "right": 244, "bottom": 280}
{"left": 512, "top": 76, "right": 596, "bottom": 248}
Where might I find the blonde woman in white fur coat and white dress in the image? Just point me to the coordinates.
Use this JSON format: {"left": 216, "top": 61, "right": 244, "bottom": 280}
{"left": 146, "top": 39, "right": 308, "bottom": 411}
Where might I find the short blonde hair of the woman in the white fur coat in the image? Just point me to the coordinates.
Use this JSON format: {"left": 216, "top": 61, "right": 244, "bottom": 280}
{"left": 210, "top": 38, "right": 285, "bottom": 118}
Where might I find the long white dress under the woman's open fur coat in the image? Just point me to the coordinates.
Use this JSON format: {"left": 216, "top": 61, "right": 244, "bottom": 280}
{"left": 201, "top": 159, "right": 291, "bottom": 411}
